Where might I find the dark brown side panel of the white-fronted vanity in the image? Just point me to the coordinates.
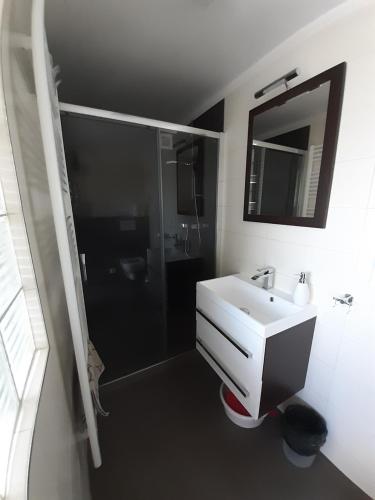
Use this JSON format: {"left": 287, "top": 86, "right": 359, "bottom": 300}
{"left": 259, "top": 318, "right": 316, "bottom": 416}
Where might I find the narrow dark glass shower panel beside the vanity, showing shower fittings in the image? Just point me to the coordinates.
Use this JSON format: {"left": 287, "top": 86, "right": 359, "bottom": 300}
{"left": 160, "top": 131, "right": 218, "bottom": 356}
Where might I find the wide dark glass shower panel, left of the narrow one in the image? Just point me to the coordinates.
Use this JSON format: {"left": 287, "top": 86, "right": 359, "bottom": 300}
{"left": 62, "top": 115, "right": 166, "bottom": 382}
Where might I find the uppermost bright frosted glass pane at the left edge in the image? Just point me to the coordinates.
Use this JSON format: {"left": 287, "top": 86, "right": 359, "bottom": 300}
{"left": 0, "top": 216, "right": 21, "bottom": 318}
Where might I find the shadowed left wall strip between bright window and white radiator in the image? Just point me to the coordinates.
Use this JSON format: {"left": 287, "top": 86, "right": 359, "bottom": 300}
{"left": 1, "top": 0, "right": 90, "bottom": 500}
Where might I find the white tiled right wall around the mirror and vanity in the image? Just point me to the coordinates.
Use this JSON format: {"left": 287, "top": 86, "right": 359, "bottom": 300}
{"left": 219, "top": 2, "right": 375, "bottom": 497}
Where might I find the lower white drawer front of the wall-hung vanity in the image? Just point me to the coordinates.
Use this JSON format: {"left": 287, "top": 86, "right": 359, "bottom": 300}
{"left": 196, "top": 311, "right": 262, "bottom": 396}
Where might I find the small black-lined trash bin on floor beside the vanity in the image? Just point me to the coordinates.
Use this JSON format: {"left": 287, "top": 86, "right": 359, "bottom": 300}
{"left": 282, "top": 405, "right": 328, "bottom": 467}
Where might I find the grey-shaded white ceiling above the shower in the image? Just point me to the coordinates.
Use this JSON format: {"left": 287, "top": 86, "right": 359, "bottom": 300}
{"left": 46, "top": 0, "right": 343, "bottom": 122}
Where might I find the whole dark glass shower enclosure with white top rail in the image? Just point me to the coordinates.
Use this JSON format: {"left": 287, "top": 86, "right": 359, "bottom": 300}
{"left": 61, "top": 105, "right": 219, "bottom": 381}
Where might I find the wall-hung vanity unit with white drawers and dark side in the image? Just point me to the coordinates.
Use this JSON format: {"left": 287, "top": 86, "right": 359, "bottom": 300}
{"left": 196, "top": 277, "right": 315, "bottom": 418}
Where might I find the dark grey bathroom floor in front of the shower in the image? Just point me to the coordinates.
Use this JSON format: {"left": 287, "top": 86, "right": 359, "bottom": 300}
{"left": 91, "top": 352, "right": 368, "bottom": 500}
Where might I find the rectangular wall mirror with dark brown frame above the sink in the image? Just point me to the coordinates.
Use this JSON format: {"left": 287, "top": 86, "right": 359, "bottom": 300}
{"left": 244, "top": 63, "right": 346, "bottom": 228}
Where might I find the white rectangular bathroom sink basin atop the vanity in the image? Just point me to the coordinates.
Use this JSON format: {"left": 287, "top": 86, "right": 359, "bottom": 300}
{"left": 197, "top": 274, "right": 316, "bottom": 338}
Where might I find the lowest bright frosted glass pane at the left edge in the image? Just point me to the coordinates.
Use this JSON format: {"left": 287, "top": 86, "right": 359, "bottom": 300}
{"left": 0, "top": 339, "right": 18, "bottom": 497}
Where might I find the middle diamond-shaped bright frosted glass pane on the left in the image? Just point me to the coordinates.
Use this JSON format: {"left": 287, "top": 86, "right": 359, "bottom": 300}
{"left": 0, "top": 292, "right": 35, "bottom": 397}
